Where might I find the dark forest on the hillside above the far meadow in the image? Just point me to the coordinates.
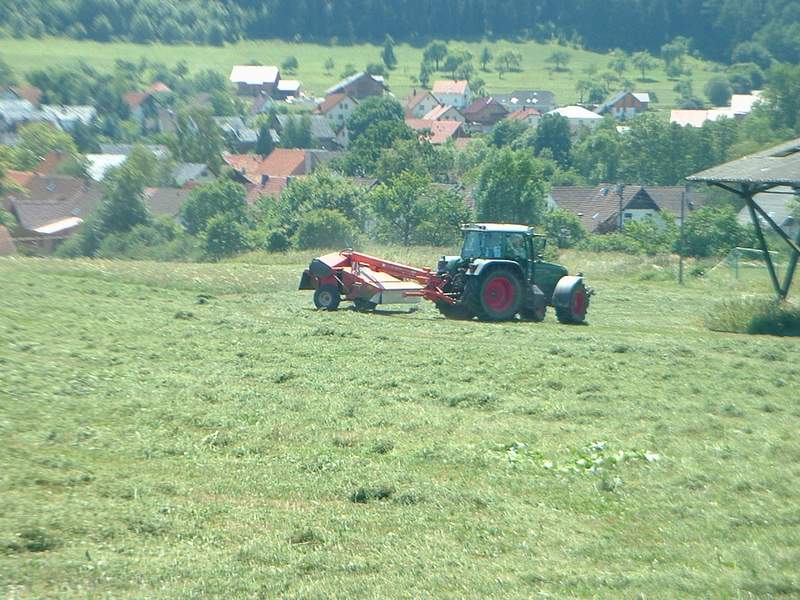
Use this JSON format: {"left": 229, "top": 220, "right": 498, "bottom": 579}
{"left": 0, "top": 0, "right": 800, "bottom": 63}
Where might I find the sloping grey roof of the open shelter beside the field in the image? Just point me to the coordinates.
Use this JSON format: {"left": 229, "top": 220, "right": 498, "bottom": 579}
{"left": 686, "top": 138, "right": 800, "bottom": 188}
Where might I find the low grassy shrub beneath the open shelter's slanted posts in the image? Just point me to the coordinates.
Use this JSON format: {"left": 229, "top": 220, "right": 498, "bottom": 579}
{"left": 706, "top": 298, "right": 800, "bottom": 336}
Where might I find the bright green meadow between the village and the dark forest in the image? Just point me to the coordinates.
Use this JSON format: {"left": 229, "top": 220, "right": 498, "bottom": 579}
{"left": 0, "top": 38, "right": 719, "bottom": 108}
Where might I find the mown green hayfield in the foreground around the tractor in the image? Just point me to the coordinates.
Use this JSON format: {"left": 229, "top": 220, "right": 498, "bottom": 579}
{"left": 0, "top": 250, "right": 800, "bottom": 599}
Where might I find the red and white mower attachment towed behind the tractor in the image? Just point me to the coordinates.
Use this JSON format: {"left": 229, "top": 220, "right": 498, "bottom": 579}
{"left": 299, "top": 250, "right": 455, "bottom": 310}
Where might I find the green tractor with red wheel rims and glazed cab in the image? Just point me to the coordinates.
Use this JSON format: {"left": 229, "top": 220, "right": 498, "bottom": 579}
{"left": 436, "top": 223, "right": 593, "bottom": 323}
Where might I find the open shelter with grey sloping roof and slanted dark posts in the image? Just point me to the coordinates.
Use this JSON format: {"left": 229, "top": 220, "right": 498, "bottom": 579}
{"left": 686, "top": 138, "right": 800, "bottom": 300}
